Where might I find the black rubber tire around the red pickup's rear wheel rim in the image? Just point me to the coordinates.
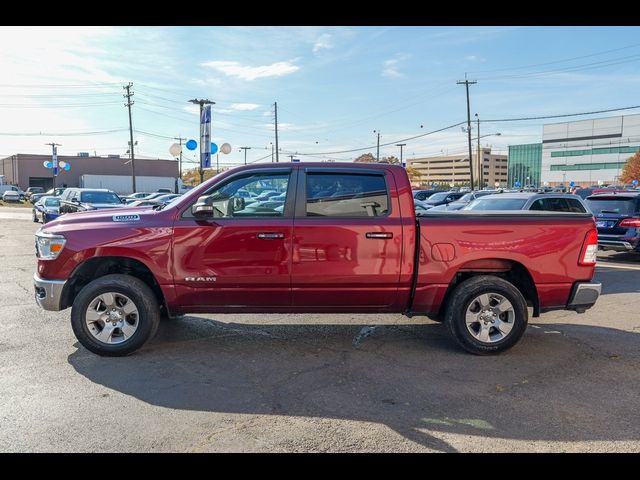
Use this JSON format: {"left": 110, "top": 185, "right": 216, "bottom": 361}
{"left": 444, "top": 275, "right": 529, "bottom": 355}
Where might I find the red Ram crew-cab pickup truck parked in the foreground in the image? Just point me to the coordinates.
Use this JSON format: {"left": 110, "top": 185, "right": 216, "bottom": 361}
{"left": 34, "top": 163, "right": 600, "bottom": 356}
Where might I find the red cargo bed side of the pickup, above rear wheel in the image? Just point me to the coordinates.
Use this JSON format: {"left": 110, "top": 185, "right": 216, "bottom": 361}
{"left": 410, "top": 211, "right": 594, "bottom": 315}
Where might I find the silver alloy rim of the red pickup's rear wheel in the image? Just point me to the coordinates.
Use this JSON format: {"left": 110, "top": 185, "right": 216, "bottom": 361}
{"left": 465, "top": 293, "right": 516, "bottom": 343}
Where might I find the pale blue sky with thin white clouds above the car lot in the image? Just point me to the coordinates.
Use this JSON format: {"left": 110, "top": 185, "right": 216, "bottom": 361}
{"left": 0, "top": 26, "right": 640, "bottom": 169}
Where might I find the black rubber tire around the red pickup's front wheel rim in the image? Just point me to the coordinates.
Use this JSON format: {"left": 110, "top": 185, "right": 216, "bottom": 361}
{"left": 71, "top": 274, "right": 160, "bottom": 357}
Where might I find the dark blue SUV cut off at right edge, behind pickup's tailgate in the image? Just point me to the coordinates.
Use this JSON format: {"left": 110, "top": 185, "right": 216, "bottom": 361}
{"left": 585, "top": 192, "right": 640, "bottom": 253}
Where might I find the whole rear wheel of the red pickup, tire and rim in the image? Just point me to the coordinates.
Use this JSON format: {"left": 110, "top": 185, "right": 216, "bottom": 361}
{"left": 444, "top": 275, "right": 529, "bottom": 355}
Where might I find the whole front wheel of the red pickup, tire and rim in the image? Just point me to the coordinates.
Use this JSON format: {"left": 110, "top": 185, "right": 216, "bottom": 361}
{"left": 71, "top": 274, "right": 160, "bottom": 357}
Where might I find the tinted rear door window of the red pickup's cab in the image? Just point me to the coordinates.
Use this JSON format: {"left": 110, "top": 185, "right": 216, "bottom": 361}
{"left": 306, "top": 173, "right": 389, "bottom": 217}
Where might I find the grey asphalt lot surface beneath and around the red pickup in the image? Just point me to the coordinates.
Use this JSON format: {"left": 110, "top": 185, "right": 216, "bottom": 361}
{"left": 0, "top": 209, "right": 640, "bottom": 452}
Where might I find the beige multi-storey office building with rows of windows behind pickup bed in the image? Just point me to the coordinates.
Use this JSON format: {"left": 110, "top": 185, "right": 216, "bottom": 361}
{"left": 407, "top": 148, "right": 508, "bottom": 187}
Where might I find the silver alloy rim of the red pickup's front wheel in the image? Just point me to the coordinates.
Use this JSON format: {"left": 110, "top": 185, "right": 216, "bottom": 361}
{"left": 85, "top": 292, "right": 140, "bottom": 345}
